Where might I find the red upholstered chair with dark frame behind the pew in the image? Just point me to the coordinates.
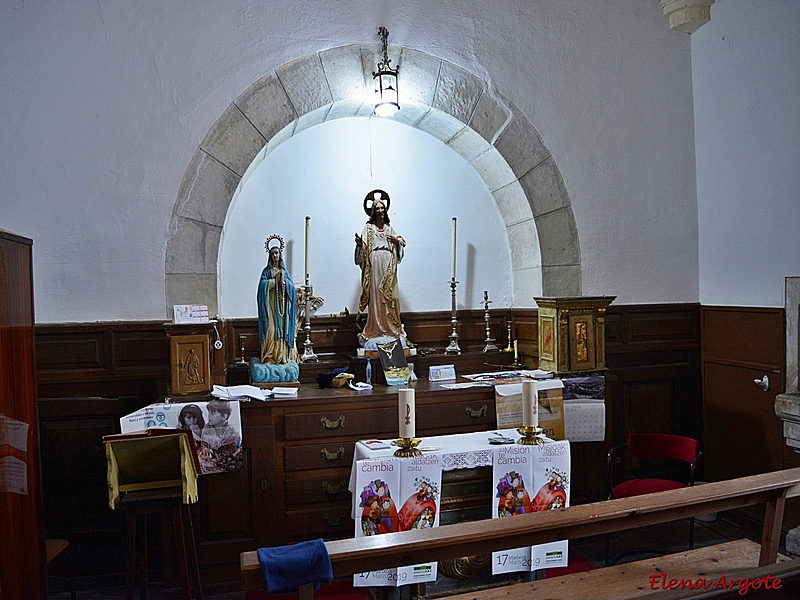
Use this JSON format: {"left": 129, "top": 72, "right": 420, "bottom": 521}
{"left": 605, "top": 433, "right": 703, "bottom": 565}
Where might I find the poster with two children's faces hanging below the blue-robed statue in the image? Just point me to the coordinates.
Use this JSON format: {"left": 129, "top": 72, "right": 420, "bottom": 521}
{"left": 119, "top": 400, "right": 242, "bottom": 474}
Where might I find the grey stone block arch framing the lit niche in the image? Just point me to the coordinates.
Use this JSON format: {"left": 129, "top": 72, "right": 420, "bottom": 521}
{"left": 165, "top": 44, "right": 581, "bottom": 315}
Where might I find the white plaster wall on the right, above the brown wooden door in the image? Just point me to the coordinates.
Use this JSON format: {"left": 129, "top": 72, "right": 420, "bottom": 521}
{"left": 692, "top": 0, "right": 800, "bottom": 307}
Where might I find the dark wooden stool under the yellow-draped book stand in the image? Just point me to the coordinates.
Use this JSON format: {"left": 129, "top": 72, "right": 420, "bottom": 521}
{"left": 119, "top": 488, "right": 203, "bottom": 600}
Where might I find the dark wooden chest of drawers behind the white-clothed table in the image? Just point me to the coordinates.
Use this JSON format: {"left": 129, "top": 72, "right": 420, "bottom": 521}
{"left": 191, "top": 382, "right": 495, "bottom": 584}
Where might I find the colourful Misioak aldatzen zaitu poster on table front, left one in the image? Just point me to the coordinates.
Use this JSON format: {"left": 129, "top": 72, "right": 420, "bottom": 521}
{"left": 353, "top": 454, "right": 442, "bottom": 587}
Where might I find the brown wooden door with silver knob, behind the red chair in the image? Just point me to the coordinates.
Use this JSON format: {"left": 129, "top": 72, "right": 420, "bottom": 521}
{"left": 702, "top": 307, "right": 785, "bottom": 481}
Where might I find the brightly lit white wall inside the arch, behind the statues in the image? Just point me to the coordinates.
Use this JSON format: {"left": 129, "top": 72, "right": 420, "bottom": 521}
{"left": 217, "top": 118, "right": 512, "bottom": 318}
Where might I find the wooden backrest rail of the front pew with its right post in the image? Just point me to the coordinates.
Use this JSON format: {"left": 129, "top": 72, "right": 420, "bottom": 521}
{"left": 240, "top": 467, "right": 800, "bottom": 598}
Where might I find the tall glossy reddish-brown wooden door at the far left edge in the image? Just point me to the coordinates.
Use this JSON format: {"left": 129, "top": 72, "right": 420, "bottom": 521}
{"left": 0, "top": 231, "right": 47, "bottom": 600}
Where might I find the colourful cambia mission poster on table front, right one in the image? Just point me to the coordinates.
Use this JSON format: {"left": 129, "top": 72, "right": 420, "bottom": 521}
{"left": 492, "top": 441, "right": 570, "bottom": 575}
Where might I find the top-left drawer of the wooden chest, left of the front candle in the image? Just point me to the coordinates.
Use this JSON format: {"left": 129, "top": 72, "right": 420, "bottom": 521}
{"left": 283, "top": 406, "right": 397, "bottom": 440}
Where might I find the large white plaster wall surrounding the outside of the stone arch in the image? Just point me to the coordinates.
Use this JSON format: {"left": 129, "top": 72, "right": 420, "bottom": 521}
{"left": 0, "top": 0, "right": 700, "bottom": 322}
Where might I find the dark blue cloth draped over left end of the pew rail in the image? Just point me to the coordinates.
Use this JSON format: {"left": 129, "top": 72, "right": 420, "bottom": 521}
{"left": 258, "top": 539, "right": 333, "bottom": 594}
